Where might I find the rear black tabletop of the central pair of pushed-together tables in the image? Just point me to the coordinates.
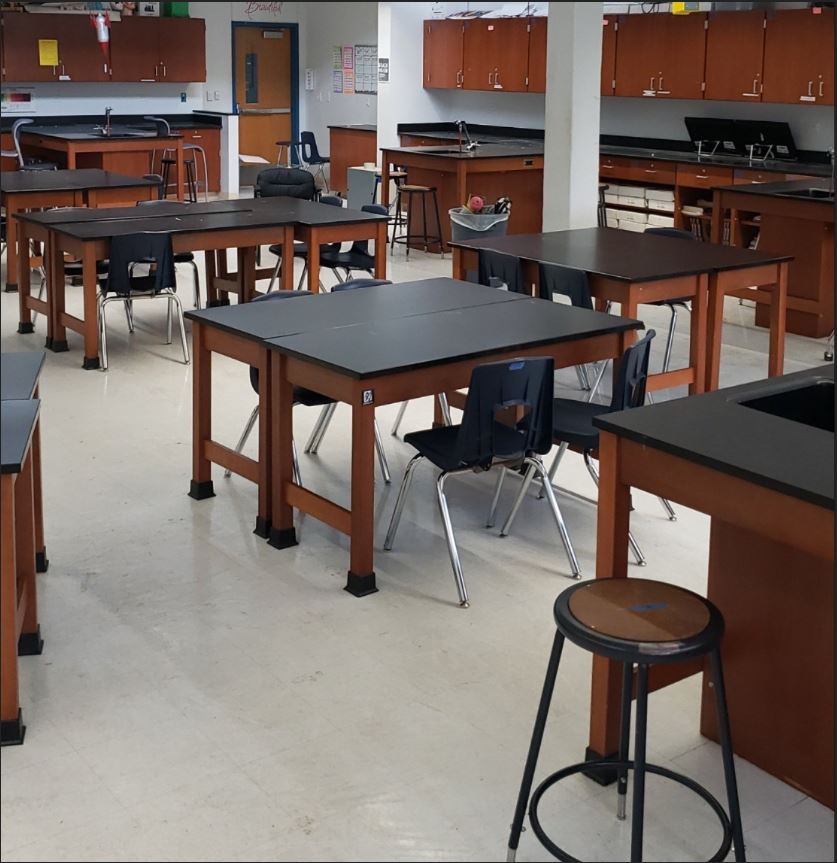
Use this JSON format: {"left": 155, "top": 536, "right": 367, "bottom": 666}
{"left": 184, "top": 278, "right": 524, "bottom": 341}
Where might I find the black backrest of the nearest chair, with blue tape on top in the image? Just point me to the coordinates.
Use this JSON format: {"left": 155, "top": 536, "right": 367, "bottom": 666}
{"left": 456, "top": 357, "right": 554, "bottom": 470}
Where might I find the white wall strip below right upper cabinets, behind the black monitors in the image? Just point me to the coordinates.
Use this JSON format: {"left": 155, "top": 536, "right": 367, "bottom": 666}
{"left": 602, "top": 96, "right": 834, "bottom": 150}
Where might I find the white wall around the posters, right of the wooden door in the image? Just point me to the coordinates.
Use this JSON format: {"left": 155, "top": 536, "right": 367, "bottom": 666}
{"left": 299, "top": 3, "right": 378, "bottom": 153}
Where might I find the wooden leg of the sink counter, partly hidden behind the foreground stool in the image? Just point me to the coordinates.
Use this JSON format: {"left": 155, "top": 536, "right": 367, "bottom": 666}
{"left": 586, "top": 432, "right": 631, "bottom": 782}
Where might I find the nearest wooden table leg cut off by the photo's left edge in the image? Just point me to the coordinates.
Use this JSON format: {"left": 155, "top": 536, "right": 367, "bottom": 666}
{"left": 0, "top": 473, "right": 26, "bottom": 744}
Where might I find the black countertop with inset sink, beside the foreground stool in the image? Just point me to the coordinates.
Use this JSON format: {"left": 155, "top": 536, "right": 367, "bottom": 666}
{"left": 594, "top": 365, "right": 834, "bottom": 510}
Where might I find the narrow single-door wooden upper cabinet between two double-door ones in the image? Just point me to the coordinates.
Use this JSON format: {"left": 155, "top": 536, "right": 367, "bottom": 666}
{"left": 703, "top": 11, "right": 765, "bottom": 102}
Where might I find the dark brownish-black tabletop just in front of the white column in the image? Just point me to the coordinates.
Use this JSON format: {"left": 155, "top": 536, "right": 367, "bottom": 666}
{"left": 450, "top": 228, "right": 793, "bottom": 282}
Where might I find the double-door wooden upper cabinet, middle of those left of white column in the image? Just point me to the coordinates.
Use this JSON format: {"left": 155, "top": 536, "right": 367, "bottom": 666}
{"left": 464, "top": 18, "right": 529, "bottom": 93}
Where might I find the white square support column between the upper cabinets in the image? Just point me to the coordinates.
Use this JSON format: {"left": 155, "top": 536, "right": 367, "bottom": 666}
{"left": 543, "top": 2, "right": 602, "bottom": 231}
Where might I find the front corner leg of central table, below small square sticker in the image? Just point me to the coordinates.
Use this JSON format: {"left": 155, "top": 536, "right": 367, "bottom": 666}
{"left": 345, "top": 391, "right": 378, "bottom": 596}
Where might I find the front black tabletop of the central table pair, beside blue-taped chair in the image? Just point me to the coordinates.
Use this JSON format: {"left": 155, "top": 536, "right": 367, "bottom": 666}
{"left": 267, "top": 296, "right": 642, "bottom": 379}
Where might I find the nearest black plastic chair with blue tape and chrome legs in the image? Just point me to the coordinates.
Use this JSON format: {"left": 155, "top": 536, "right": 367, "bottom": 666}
{"left": 384, "top": 357, "right": 580, "bottom": 608}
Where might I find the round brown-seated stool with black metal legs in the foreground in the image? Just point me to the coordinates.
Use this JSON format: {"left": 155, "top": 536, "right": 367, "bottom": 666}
{"left": 507, "top": 578, "right": 745, "bottom": 861}
